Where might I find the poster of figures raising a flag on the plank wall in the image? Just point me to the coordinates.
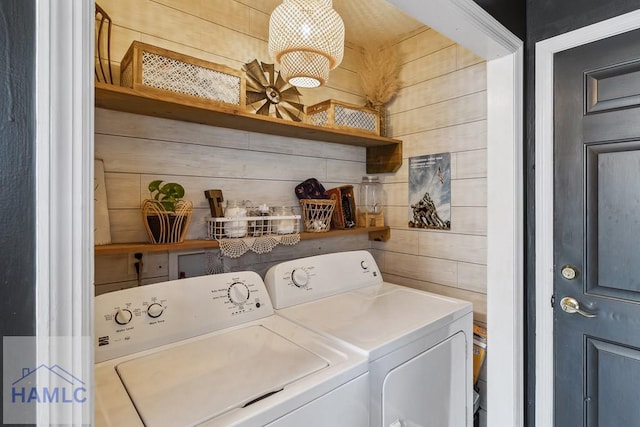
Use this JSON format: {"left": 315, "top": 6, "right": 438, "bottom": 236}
{"left": 409, "top": 153, "right": 451, "bottom": 230}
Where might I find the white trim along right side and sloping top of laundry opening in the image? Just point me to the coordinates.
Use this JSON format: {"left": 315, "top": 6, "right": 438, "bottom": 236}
{"left": 382, "top": 0, "right": 524, "bottom": 427}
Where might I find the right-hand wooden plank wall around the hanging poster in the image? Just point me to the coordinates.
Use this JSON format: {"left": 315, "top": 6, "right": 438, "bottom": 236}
{"left": 373, "top": 29, "right": 487, "bottom": 322}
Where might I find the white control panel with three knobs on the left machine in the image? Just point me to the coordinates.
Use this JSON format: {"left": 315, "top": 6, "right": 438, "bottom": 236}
{"left": 94, "top": 271, "right": 273, "bottom": 362}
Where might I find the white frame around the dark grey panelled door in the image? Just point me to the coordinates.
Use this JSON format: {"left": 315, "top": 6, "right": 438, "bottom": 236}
{"left": 535, "top": 10, "right": 640, "bottom": 425}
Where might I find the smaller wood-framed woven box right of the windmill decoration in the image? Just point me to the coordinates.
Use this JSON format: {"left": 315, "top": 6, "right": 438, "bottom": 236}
{"left": 307, "top": 99, "right": 380, "bottom": 135}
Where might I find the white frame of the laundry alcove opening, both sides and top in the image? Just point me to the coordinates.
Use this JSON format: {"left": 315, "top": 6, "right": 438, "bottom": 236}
{"left": 35, "top": 0, "right": 524, "bottom": 427}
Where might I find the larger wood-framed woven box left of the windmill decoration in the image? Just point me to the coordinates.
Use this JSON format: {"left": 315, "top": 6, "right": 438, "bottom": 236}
{"left": 120, "top": 41, "right": 246, "bottom": 107}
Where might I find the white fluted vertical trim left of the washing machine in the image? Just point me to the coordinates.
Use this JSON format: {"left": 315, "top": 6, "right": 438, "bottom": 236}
{"left": 35, "top": 0, "right": 94, "bottom": 425}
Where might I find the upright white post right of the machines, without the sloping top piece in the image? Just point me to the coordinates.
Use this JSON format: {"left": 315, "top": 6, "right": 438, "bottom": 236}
{"left": 487, "top": 48, "right": 524, "bottom": 426}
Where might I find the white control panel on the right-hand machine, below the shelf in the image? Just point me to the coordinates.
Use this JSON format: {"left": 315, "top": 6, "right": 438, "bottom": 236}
{"left": 264, "top": 251, "right": 383, "bottom": 309}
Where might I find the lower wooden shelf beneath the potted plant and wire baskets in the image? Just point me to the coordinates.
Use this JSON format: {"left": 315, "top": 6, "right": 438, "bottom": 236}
{"left": 94, "top": 227, "right": 391, "bottom": 256}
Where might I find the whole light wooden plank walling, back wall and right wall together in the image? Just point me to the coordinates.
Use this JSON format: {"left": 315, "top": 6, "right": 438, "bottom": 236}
{"left": 96, "top": 0, "right": 487, "bottom": 321}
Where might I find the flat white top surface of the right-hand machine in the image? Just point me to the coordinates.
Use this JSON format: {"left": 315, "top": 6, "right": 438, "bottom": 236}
{"left": 278, "top": 283, "right": 472, "bottom": 360}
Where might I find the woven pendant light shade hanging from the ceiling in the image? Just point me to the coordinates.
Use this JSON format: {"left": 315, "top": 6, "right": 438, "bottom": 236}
{"left": 269, "top": 0, "right": 344, "bottom": 87}
